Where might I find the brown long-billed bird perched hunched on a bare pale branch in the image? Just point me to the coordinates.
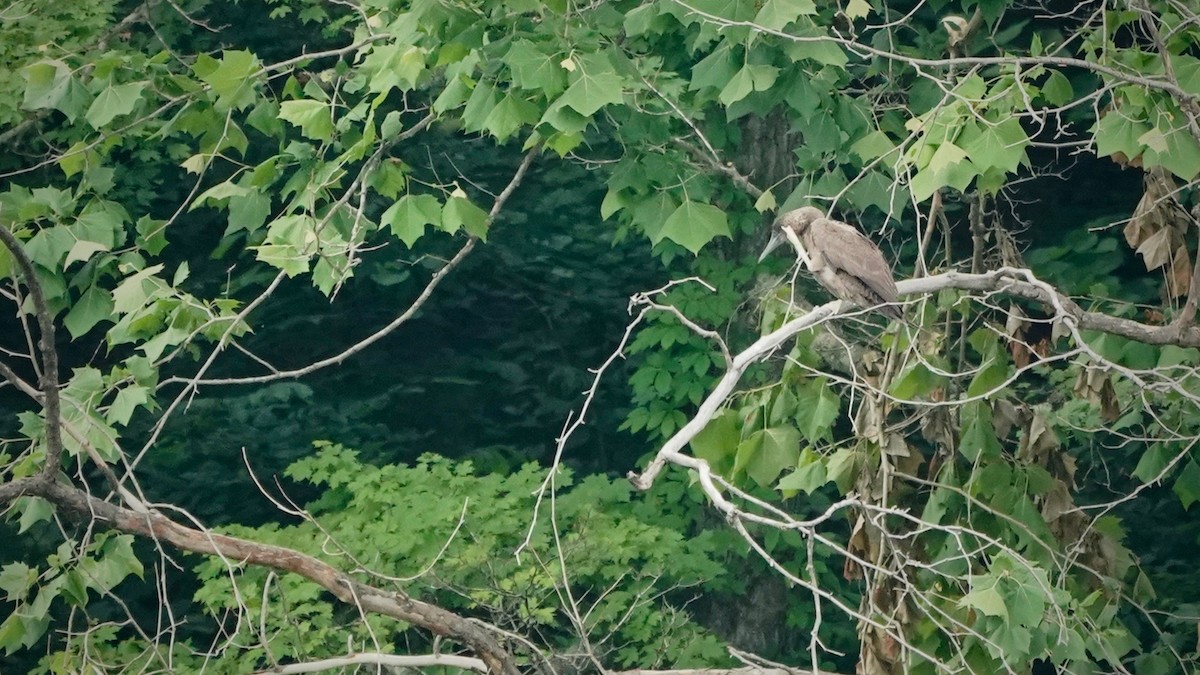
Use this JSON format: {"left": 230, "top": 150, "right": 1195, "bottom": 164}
{"left": 758, "top": 207, "right": 902, "bottom": 319}
